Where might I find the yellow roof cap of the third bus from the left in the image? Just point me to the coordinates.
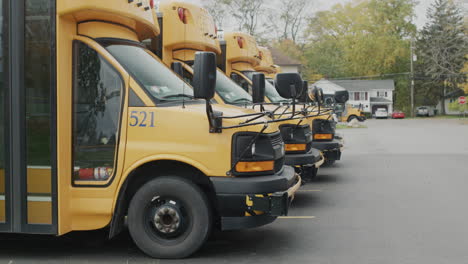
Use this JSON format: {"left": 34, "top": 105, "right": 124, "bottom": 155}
{"left": 224, "top": 32, "right": 261, "bottom": 67}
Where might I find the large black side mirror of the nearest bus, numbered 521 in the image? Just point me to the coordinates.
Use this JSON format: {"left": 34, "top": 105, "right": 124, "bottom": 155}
{"left": 193, "top": 52, "right": 216, "bottom": 100}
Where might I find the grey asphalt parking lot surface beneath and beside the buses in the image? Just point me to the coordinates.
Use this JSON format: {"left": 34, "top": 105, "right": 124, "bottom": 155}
{"left": 0, "top": 119, "right": 468, "bottom": 264}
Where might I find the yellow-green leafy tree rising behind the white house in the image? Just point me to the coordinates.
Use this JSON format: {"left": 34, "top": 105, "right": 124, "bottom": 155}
{"left": 305, "top": 0, "right": 416, "bottom": 78}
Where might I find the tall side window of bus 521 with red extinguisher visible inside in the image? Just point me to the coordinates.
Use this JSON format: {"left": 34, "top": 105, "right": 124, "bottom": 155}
{"left": 73, "top": 41, "right": 124, "bottom": 181}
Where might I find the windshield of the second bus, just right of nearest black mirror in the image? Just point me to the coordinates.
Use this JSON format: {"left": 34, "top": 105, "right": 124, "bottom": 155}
{"left": 216, "top": 70, "right": 252, "bottom": 104}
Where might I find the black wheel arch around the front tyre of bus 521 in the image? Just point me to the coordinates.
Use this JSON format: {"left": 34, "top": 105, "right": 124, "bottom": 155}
{"left": 109, "top": 160, "right": 217, "bottom": 238}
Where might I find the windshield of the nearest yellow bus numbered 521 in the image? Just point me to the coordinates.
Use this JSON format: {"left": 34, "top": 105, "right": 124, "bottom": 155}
{"left": 105, "top": 41, "right": 193, "bottom": 102}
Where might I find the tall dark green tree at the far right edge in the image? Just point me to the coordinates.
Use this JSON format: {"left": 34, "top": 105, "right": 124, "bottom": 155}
{"left": 418, "top": 0, "right": 468, "bottom": 114}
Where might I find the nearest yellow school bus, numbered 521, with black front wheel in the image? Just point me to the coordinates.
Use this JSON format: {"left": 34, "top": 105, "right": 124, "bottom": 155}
{"left": 0, "top": 0, "right": 301, "bottom": 258}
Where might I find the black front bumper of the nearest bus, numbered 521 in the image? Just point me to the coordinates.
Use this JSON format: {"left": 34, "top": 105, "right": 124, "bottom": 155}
{"left": 210, "top": 166, "right": 301, "bottom": 230}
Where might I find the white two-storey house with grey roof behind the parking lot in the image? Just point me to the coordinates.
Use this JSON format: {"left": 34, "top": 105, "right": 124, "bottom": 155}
{"left": 331, "top": 80, "right": 395, "bottom": 114}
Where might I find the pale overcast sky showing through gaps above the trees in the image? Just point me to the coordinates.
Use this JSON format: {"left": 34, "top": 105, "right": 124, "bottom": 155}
{"left": 174, "top": 0, "right": 468, "bottom": 28}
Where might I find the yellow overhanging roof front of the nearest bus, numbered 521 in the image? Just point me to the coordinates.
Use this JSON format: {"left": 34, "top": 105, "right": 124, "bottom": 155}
{"left": 57, "top": 0, "right": 160, "bottom": 40}
